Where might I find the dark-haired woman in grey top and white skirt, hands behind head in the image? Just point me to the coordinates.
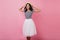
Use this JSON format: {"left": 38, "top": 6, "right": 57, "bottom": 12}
{"left": 19, "top": 3, "right": 40, "bottom": 40}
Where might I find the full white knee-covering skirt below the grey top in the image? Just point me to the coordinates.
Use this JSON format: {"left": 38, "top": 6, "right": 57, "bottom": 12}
{"left": 23, "top": 19, "right": 37, "bottom": 37}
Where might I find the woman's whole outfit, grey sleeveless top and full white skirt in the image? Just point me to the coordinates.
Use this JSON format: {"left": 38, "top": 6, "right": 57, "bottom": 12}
{"left": 23, "top": 11, "right": 37, "bottom": 37}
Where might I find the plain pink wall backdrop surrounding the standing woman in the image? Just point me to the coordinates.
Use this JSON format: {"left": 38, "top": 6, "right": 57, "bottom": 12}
{"left": 0, "top": 0, "right": 60, "bottom": 40}
